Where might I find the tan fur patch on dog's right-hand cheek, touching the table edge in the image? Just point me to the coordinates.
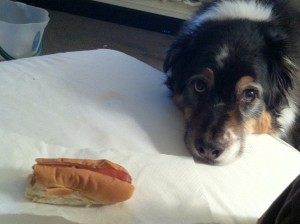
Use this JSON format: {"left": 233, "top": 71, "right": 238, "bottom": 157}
{"left": 245, "top": 111, "right": 274, "bottom": 134}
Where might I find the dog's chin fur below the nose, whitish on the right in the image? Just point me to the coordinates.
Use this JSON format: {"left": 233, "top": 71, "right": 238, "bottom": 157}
{"left": 187, "top": 140, "right": 244, "bottom": 165}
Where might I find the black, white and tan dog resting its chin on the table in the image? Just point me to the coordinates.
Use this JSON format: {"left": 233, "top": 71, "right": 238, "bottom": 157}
{"left": 163, "top": 0, "right": 300, "bottom": 164}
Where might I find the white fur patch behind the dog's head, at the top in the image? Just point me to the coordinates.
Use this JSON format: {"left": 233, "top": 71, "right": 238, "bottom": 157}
{"left": 193, "top": 0, "right": 272, "bottom": 26}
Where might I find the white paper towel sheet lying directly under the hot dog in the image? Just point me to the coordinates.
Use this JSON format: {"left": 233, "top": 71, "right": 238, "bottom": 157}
{"left": 0, "top": 130, "right": 212, "bottom": 224}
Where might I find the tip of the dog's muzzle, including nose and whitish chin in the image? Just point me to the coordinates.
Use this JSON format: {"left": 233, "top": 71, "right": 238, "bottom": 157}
{"left": 185, "top": 126, "right": 244, "bottom": 165}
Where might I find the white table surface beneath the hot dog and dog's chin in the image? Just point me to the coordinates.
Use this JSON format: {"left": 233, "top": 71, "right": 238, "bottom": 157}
{"left": 0, "top": 50, "right": 300, "bottom": 224}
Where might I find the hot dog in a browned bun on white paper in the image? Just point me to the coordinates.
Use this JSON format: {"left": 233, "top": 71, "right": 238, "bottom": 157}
{"left": 25, "top": 158, "right": 134, "bottom": 206}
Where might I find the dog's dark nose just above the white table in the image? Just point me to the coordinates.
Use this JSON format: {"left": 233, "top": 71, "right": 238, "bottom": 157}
{"left": 195, "top": 139, "right": 224, "bottom": 160}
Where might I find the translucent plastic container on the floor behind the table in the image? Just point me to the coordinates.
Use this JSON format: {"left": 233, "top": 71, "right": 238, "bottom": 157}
{"left": 0, "top": 0, "right": 49, "bottom": 60}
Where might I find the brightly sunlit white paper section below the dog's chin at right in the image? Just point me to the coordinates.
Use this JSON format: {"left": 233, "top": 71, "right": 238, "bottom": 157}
{"left": 196, "top": 135, "right": 300, "bottom": 224}
